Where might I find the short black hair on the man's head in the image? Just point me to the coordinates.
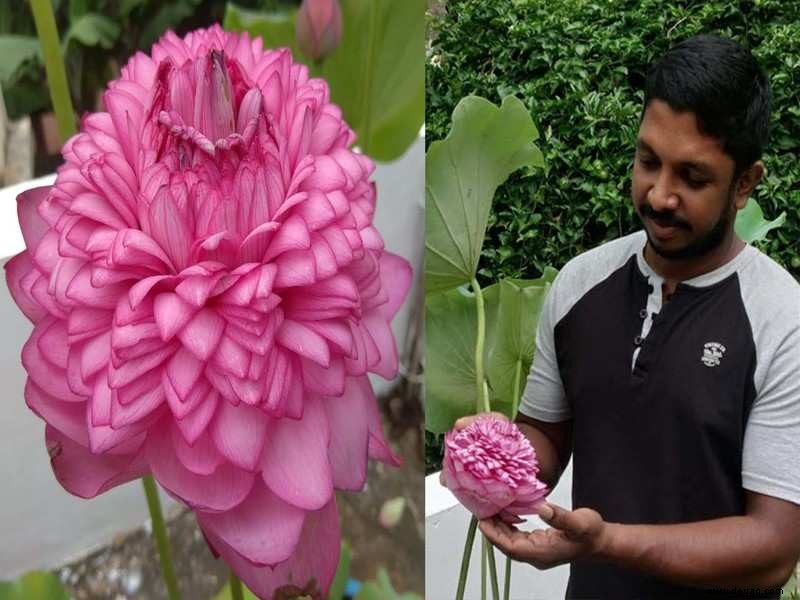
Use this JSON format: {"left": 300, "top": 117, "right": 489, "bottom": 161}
{"left": 642, "top": 35, "right": 772, "bottom": 179}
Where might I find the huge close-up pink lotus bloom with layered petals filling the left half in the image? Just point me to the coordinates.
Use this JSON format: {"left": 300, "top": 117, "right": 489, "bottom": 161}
{"left": 6, "top": 27, "right": 411, "bottom": 598}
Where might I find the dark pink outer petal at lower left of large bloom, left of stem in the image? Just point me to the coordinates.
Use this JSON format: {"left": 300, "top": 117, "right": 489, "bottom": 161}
{"left": 45, "top": 425, "right": 148, "bottom": 498}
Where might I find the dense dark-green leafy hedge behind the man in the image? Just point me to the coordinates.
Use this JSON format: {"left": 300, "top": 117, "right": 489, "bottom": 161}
{"left": 426, "top": 0, "right": 800, "bottom": 280}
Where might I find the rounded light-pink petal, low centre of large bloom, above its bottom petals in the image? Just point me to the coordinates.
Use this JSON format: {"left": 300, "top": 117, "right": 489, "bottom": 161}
{"left": 210, "top": 402, "right": 269, "bottom": 471}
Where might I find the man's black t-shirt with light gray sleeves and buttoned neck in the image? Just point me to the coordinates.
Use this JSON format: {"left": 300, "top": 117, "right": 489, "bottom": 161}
{"left": 520, "top": 231, "right": 800, "bottom": 600}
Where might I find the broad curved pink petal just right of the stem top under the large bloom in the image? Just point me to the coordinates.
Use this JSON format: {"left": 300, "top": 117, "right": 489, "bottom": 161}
{"left": 146, "top": 426, "right": 255, "bottom": 511}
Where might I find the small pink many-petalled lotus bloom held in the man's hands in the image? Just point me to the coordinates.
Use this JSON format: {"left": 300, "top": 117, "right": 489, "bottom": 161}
{"left": 442, "top": 415, "right": 548, "bottom": 523}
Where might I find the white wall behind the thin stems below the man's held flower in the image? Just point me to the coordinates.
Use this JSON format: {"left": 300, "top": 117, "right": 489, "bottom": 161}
{"left": 425, "top": 461, "right": 572, "bottom": 600}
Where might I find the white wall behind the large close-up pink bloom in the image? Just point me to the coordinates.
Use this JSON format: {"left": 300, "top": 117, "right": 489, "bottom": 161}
{"left": 0, "top": 138, "right": 425, "bottom": 579}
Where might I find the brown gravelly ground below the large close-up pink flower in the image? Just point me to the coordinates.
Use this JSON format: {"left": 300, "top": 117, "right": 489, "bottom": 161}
{"left": 55, "top": 390, "right": 425, "bottom": 600}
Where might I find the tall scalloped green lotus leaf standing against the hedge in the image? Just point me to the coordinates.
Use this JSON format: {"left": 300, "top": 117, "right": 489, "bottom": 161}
{"left": 425, "top": 96, "right": 543, "bottom": 293}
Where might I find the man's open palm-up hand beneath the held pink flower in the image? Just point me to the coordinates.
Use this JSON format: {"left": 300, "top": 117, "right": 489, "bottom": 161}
{"left": 480, "top": 503, "right": 607, "bottom": 570}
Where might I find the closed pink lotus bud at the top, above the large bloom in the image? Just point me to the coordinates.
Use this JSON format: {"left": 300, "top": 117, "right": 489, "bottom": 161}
{"left": 295, "top": 0, "right": 342, "bottom": 62}
